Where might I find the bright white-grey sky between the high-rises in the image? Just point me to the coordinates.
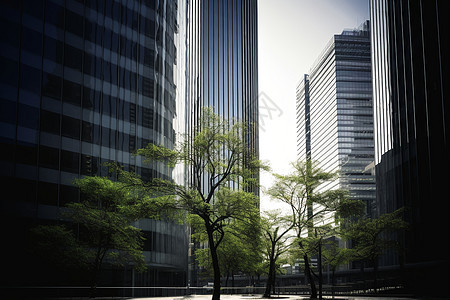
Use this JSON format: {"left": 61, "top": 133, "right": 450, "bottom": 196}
{"left": 258, "top": 0, "right": 369, "bottom": 211}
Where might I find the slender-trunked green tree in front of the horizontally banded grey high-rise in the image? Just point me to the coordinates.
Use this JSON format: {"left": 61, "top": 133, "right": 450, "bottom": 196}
{"left": 268, "top": 159, "right": 356, "bottom": 298}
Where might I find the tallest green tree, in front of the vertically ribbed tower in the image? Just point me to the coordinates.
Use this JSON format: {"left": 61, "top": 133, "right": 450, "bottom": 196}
{"left": 137, "top": 108, "right": 264, "bottom": 300}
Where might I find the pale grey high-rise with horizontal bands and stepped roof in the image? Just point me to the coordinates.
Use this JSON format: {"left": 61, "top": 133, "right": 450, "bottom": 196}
{"left": 297, "top": 21, "right": 375, "bottom": 216}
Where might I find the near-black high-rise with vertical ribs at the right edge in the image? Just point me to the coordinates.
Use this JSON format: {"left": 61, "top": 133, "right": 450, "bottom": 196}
{"left": 370, "top": 0, "right": 450, "bottom": 296}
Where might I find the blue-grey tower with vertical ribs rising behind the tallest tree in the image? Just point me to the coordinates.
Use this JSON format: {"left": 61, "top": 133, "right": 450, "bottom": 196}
{"left": 186, "top": 0, "right": 259, "bottom": 286}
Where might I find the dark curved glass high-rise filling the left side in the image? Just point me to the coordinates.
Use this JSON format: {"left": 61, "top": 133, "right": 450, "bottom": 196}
{"left": 0, "top": 0, "right": 188, "bottom": 286}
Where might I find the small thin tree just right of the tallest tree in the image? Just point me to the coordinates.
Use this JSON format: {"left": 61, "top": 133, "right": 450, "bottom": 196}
{"left": 261, "top": 211, "right": 293, "bottom": 298}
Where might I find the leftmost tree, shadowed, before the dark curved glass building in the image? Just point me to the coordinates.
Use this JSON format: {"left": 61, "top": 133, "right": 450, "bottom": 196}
{"left": 33, "top": 177, "right": 171, "bottom": 297}
